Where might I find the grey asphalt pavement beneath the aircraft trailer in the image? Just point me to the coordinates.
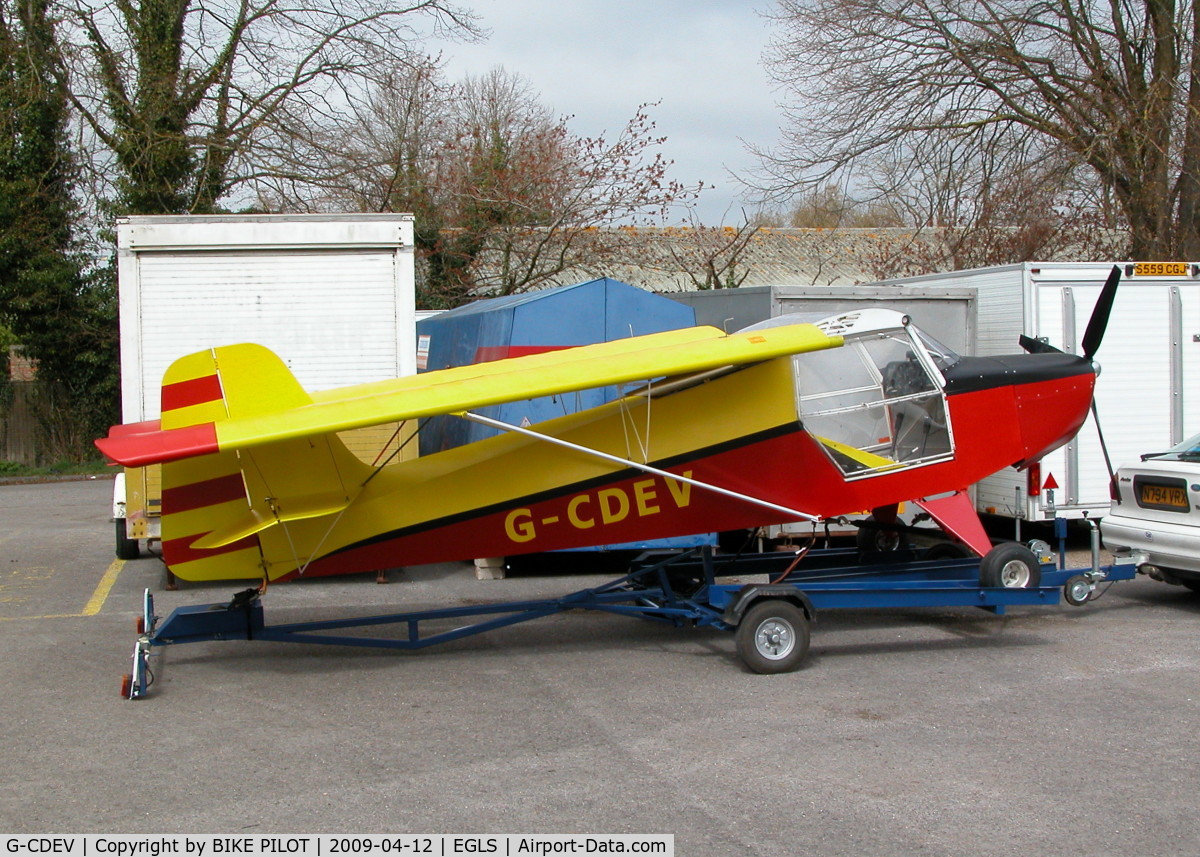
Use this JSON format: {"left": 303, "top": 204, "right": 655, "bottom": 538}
{"left": 0, "top": 479, "right": 1200, "bottom": 857}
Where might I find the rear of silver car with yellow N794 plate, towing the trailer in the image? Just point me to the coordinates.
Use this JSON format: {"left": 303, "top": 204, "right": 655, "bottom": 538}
{"left": 1100, "top": 435, "right": 1200, "bottom": 592}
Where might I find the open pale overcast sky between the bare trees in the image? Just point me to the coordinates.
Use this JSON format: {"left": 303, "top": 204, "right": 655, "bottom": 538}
{"left": 427, "top": 0, "right": 779, "bottom": 226}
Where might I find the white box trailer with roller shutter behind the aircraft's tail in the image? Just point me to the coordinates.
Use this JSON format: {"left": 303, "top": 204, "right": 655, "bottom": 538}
{"left": 113, "top": 214, "right": 416, "bottom": 558}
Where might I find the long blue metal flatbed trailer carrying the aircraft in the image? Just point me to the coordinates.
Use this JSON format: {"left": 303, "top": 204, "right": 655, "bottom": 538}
{"left": 121, "top": 534, "right": 1136, "bottom": 699}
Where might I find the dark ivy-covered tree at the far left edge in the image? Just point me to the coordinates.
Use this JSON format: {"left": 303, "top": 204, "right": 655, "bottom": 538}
{"left": 0, "top": 0, "right": 120, "bottom": 461}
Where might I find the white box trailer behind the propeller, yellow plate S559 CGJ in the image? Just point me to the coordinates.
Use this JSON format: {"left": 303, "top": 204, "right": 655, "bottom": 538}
{"left": 869, "top": 262, "right": 1200, "bottom": 521}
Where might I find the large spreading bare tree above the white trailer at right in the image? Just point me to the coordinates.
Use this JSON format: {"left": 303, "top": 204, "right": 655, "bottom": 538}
{"left": 760, "top": 0, "right": 1200, "bottom": 258}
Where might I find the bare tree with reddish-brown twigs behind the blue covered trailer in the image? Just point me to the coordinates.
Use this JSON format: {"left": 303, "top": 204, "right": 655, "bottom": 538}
{"left": 271, "top": 61, "right": 698, "bottom": 307}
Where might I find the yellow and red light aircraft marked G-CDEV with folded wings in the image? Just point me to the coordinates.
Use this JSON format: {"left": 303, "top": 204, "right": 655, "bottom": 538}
{"left": 97, "top": 271, "right": 1120, "bottom": 581}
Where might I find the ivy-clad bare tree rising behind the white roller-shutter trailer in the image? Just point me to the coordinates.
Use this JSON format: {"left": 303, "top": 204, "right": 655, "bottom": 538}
{"left": 61, "top": 0, "right": 478, "bottom": 214}
